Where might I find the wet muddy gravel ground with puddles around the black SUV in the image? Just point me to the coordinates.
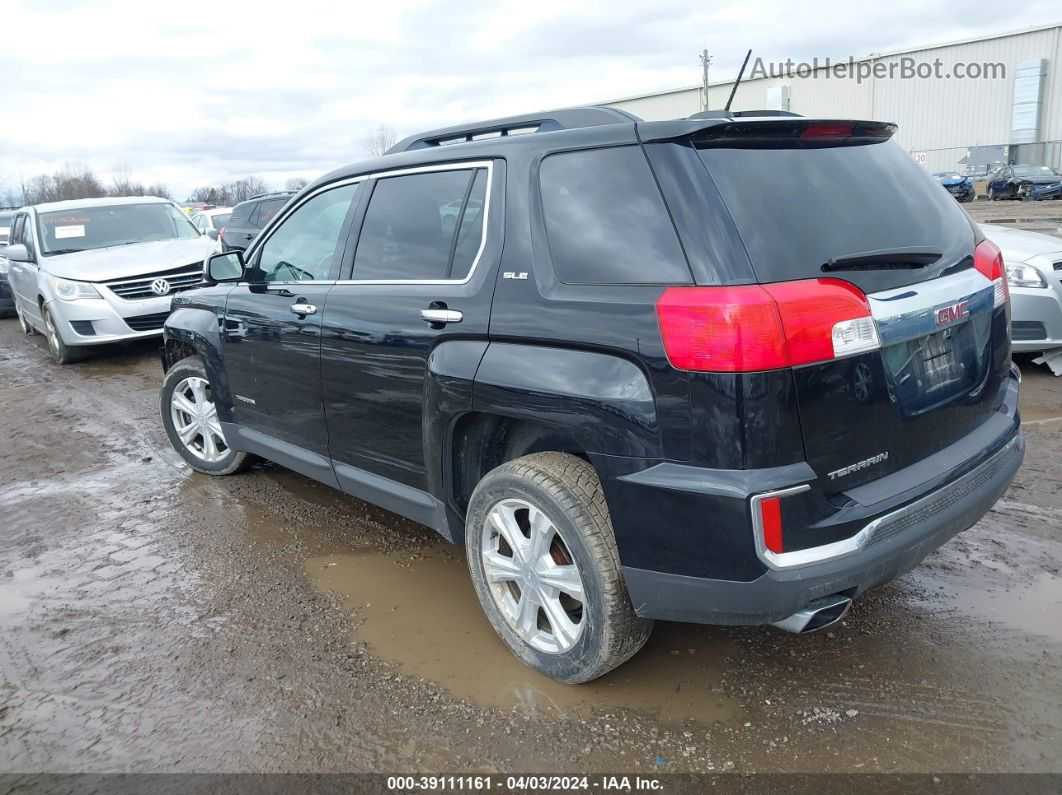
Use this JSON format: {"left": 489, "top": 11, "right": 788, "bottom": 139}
{"left": 0, "top": 321, "right": 1062, "bottom": 773}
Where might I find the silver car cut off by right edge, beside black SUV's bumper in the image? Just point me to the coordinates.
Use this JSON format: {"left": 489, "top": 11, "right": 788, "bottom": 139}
{"left": 981, "top": 219, "right": 1062, "bottom": 352}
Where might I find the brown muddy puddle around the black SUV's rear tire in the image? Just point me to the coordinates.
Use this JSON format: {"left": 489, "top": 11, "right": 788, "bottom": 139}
{"left": 306, "top": 546, "right": 739, "bottom": 723}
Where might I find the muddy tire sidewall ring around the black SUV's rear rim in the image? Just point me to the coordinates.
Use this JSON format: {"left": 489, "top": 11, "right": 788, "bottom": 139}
{"left": 465, "top": 471, "right": 606, "bottom": 681}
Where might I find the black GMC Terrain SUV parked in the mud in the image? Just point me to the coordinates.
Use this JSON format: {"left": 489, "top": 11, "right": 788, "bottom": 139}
{"left": 161, "top": 108, "right": 1024, "bottom": 682}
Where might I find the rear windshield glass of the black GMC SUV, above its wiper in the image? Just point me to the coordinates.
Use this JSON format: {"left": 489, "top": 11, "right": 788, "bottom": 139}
{"left": 699, "top": 141, "right": 973, "bottom": 281}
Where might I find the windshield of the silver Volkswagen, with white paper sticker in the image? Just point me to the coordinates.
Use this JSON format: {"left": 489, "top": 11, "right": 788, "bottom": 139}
{"left": 37, "top": 203, "right": 200, "bottom": 254}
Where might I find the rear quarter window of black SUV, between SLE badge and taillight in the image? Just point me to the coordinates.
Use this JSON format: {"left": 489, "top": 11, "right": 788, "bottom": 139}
{"left": 539, "top": 146, "right": 691, "bottom": 284}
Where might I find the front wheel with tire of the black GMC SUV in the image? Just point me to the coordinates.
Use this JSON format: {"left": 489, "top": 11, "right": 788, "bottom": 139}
{"left": 159, "top": 357, "right": 255, "bottom": 474}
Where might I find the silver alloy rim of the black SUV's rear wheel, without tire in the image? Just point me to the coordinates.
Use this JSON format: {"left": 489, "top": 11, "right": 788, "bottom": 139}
{"left": 480, "top": 499, "right": 586, "bottom": 654}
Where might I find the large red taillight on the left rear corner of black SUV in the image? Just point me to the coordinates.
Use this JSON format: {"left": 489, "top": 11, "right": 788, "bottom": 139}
{"left": 656, "top": 279, "right": 880, "bottom": 373}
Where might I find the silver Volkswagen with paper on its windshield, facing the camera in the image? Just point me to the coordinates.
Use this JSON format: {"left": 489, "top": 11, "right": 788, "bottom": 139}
{"left": 6, "top": 196, "right": 213, "bottom": 364}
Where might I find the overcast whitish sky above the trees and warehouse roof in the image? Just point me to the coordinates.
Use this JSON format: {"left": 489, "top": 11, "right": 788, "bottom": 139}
{"left": 0, "top": 0, "right": 1062, "bottom": 197}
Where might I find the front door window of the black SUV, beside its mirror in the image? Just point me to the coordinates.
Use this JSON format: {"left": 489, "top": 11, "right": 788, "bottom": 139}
{"left": 252, "top": 184, "right": 358, "bottom": 281}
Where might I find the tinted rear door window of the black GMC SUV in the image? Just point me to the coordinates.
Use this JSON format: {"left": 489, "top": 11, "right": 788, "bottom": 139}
{"left": 354, "top": 169, "right": 474, "bottom": 280}
